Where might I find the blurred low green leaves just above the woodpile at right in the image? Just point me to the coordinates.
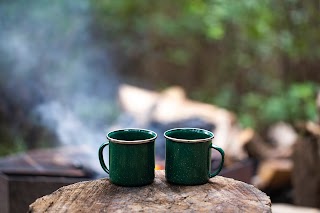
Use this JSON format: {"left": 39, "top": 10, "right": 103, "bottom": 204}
{"left": 212, "top": 83, "right": 317, "bottom": 129}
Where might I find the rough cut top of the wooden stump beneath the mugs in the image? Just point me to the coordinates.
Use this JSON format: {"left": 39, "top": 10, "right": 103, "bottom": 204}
{"left": 29, "top": 171, "right": 271, "bottom": 213}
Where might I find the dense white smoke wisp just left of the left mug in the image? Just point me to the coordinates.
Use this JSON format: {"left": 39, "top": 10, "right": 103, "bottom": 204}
{"left": 35, "top": 101, "right": 105, "bottom": 172}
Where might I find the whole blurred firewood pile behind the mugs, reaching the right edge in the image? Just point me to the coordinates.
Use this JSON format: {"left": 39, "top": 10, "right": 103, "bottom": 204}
{"left": 113, "top": 85, "right": 320, "bottom": 208}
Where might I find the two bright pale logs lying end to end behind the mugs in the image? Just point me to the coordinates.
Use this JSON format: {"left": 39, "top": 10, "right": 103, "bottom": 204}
{"left": 119, "top": 85, "right": 253, "bottom": 166}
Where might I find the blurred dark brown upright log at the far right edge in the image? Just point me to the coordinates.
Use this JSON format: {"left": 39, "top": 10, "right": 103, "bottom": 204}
{"left": 292, "top": 122, "right": 320, "bottom": 208}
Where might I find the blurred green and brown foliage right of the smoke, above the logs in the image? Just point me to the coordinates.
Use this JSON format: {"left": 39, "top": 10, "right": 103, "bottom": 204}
{"left": 92, "top": 0, "right": 320, "bottom": 128}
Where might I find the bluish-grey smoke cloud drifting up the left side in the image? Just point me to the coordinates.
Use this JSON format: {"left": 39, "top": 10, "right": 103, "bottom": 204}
{"left": 0, "top": 0, "right": 119, "bottom": 172}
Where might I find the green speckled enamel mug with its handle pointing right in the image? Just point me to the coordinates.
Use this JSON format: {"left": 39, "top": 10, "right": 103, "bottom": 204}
{"left": 164, "top": 128, "right": 224, "bottom": 185}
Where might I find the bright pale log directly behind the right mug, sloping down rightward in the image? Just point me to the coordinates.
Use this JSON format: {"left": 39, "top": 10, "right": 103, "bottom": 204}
{"left": 151, "top": 87, "right": 240, "bottom": 155}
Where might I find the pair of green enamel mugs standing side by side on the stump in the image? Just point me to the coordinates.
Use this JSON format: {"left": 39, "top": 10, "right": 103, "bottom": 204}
{"left": 98, "top": 128, "right": 224, "bottom": 186}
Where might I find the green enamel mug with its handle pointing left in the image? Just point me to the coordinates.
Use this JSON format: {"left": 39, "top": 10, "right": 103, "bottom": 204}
{"left": 98, "top": 128, "right": 157, "bottom": 186}
